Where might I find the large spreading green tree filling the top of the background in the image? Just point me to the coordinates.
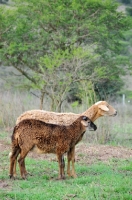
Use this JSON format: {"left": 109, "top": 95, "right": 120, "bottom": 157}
{"left": 0, "top": 0, "right": 131, "bottom": 110}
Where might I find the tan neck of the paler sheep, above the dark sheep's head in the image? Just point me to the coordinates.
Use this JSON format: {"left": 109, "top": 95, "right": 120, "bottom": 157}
{"left": 82, "top": 105, "right": 101, "bottom": 122}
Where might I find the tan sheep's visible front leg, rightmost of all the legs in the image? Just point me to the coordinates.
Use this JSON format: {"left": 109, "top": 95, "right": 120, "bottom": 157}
{"left": 67, "top": 146, "right": 77, "bottom": 178}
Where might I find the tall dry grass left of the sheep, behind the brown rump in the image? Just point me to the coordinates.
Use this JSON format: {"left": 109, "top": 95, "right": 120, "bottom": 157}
{"left": 0, "top": 91, "right": 39, "bottom": 130}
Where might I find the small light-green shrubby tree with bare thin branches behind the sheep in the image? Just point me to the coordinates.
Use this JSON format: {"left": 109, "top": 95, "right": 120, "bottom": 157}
{"left": 26, "top": 47, "right": 101, "bottom": 112}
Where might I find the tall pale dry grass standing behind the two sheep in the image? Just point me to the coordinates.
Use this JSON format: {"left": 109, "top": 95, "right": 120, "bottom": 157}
{"left": 0, "top": 92, "right": 132, "bottom": 147}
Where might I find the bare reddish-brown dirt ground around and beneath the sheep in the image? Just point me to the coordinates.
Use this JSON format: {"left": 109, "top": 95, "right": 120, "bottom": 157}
{"left": 0, "top": 140, "right": 132, "bottom": 189}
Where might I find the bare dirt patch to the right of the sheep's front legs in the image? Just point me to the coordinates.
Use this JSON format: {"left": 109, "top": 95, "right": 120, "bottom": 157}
{"left": 76, "top": 143, "right": 132, "bottom": 164}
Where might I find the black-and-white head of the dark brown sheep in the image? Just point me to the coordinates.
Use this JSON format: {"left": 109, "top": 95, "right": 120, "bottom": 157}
{"left": 81, "top": 116, "right": 97, "bottom": 131}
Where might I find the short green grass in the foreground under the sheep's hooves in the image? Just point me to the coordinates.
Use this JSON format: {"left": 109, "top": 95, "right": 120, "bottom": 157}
{"left": 0, "top": 151, "right": 132, "bottom": 200}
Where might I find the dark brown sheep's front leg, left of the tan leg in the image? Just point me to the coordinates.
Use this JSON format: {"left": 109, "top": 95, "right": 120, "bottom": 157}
{"left": 57, "top": 155, "right": 65, "bottom": 179}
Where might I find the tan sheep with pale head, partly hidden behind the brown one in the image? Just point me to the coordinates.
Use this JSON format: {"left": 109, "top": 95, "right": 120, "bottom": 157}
{"left": 14, "top": 101, "right": 117, "bottom": 177}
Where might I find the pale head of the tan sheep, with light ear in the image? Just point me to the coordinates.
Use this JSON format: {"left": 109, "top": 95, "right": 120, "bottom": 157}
{"left": 95, "top": 101, "right": 117, "bottom": 116}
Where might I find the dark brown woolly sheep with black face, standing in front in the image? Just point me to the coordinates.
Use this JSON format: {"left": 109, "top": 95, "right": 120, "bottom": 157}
{"left": 9, "top": 116, "right": 97, "bottom": 179}
